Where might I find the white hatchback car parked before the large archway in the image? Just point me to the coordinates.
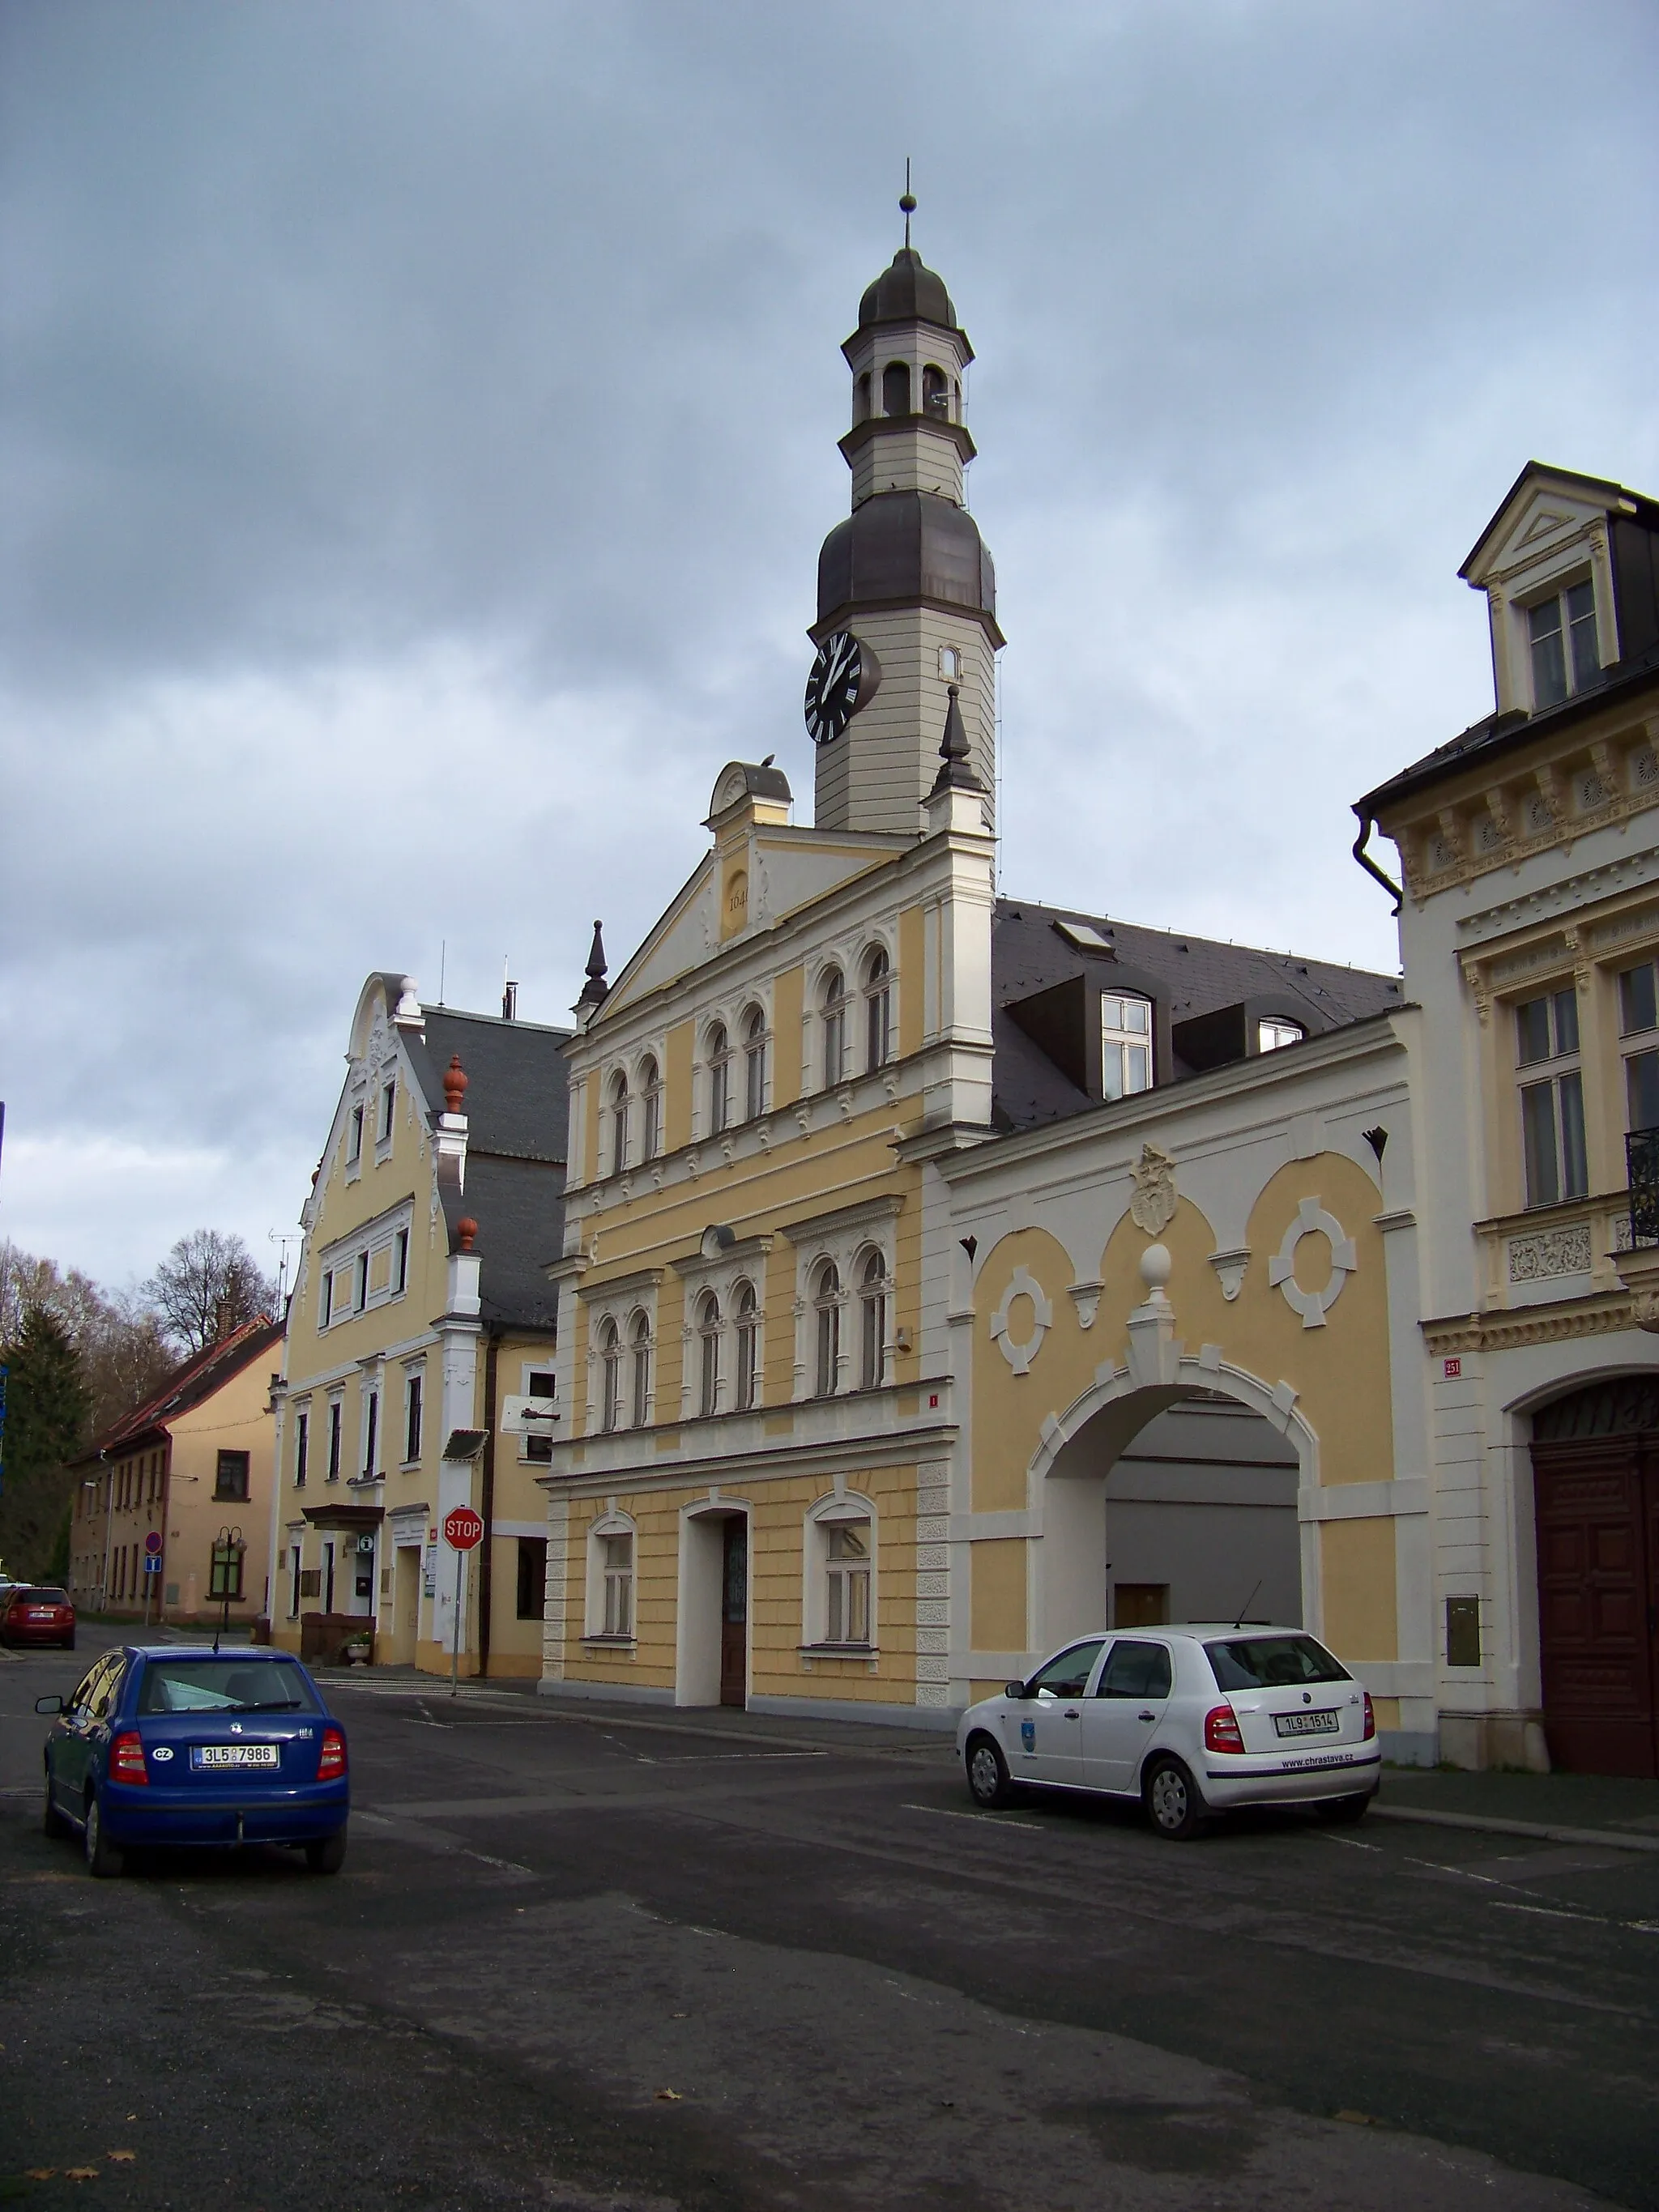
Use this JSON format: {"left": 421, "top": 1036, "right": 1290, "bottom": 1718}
{"left": 956, "top": 1622, "right": 1383, "bottom": 1840}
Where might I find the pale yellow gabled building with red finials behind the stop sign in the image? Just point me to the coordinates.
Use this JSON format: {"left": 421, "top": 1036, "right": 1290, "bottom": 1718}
{"left": 270, "top": 975, "right": 569, "bottom": 1674}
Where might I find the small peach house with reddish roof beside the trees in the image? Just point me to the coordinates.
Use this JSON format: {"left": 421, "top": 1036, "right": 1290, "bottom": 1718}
{"left": 69, "top": 1320, "right": 284, "bottom": 1626}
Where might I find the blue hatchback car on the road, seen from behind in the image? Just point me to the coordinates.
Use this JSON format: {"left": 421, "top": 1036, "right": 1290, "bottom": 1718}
{"left": 36, "top": 1643, "right": 352, "bottom": 1876}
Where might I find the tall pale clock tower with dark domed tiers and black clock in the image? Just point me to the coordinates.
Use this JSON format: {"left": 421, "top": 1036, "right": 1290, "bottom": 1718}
{"left": 808, "top": 205, "right": 1002, "bottom": 836}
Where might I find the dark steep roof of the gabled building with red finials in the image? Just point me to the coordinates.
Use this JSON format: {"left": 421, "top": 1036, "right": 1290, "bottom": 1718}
{"left": 407, "top": 1007, "right": 573, "bottom": 1329}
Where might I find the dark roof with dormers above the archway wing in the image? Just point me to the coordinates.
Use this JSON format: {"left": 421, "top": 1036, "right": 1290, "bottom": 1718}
{"left": 991, "top": 898, "right": 1405, "bottom": 1131}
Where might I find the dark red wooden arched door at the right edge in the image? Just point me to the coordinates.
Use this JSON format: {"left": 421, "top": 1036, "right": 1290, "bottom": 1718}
{"left": 1533, "top": 1376, "right": 1659, "bottom": 1776}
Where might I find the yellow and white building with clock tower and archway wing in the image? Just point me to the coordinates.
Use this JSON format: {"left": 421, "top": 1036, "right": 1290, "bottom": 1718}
{"left": 542, "top": 233, "right": 1433, "bottom": 1756}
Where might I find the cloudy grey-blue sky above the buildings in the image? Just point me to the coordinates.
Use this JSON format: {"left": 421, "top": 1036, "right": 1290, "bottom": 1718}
{"left": 0, "top": 0, "right": 1659, "bottom": 1281}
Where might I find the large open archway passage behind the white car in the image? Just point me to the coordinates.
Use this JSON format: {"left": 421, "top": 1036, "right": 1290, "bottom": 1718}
{"left": 1033, "top": 1362, "right": 1307, "bottom": 1648}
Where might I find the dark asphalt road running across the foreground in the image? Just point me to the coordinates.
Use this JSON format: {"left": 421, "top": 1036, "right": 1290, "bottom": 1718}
{"left": 0, "top": 1632, "right": 1659, "bottom": 2212}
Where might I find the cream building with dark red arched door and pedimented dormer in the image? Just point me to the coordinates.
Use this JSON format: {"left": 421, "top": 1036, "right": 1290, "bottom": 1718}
{"left": 1356, "top": 462, "right": 1659, "bottom": 1774}
